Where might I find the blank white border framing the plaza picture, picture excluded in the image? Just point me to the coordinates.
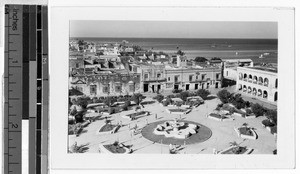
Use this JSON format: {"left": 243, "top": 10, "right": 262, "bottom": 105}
{"left": 49, "top": 6, "right": 295, "bottom": 169}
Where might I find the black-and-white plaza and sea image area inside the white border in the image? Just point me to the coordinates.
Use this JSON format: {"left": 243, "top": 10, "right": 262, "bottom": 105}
{"left": 66, "top": 20, "right": 280, "bottom": 155}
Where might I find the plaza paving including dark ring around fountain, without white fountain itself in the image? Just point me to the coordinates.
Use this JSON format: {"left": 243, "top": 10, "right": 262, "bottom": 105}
{"left": 69, "top": 95, "right": 277, "bottom": 154}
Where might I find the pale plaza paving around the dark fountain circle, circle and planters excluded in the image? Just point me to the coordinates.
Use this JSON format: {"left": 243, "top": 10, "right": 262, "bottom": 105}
{"left": 69, "top": 98, "right": 276, "bottom": 154}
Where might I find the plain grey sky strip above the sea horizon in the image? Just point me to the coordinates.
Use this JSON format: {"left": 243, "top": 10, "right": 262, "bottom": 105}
{"left": 70, "top": 20, "right": 278, "bottom": 39}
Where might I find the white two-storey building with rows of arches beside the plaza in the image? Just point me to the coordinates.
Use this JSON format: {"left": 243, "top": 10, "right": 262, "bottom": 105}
{"left": 236, "top": 67, "right": 278, "bottom": 104}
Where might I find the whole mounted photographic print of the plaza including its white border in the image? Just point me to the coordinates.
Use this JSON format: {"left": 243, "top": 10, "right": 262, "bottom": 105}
{"left": 49, "top": 5, "right": 295, "bottom": 170}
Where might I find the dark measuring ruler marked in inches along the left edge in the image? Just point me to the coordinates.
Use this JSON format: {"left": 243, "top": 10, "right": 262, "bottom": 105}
{"left": 3, "top": 5, "right": 48, "bottom": 174}
